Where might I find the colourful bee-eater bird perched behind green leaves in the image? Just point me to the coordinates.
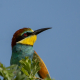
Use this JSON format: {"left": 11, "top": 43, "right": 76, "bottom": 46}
{"left": 10, "top": 27, "right": 51, "bottom": 79}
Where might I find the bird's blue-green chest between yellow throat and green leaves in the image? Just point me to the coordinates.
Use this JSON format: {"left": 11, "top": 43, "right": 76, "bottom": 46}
{"left": 11, "top": 44, "right": 34, "bottom": 64}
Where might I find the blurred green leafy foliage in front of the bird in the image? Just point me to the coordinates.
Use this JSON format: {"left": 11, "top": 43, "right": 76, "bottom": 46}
{"left": 0, "top": 57, "right": 54, "bottom": 80}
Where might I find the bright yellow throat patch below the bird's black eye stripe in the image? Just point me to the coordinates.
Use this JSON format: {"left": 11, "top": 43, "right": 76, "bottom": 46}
{"left": 17, "top": 35, "right": 37, "bottom": 46}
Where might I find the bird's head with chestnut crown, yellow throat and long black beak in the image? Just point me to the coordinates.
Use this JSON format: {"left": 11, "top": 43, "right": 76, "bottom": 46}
{"left": 11, "top": 28, "right": 51, "bottom": 47}
